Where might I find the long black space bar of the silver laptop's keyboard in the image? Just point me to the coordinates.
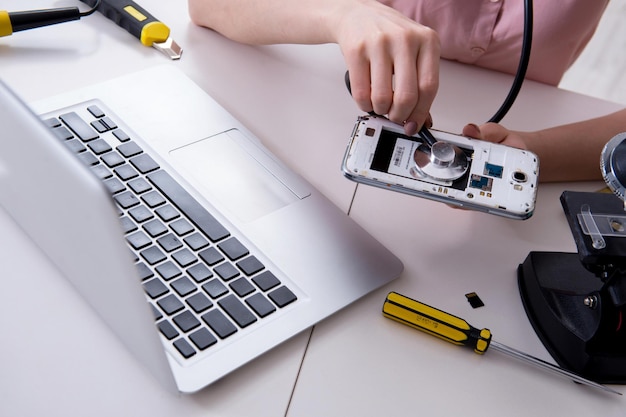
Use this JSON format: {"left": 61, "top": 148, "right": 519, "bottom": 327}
{"left": 148, "top": 170, "right": 230, "bottom": 242}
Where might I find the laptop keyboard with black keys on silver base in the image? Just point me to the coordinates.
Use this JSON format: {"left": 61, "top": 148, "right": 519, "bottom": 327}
{"left": 44, "top": 105, "right": 297, "bottom": 359}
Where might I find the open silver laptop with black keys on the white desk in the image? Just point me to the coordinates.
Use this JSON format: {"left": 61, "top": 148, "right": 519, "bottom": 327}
{"left": 0, "top": 65, "right": 402, "bottom": 392}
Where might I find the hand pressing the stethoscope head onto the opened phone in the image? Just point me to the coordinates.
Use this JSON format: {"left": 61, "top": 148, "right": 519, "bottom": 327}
{"left": 335, "top": 1, "right": 440, "bottom": 135}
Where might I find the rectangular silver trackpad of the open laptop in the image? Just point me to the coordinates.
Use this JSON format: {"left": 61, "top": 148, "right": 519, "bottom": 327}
{"left": 170, "top": 129, "right": 310, "bottom": 222}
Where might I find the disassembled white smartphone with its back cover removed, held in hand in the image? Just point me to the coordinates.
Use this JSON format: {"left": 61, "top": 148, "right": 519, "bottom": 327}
{"left": 342, "top": 115, "right": 539, "bottom": 220}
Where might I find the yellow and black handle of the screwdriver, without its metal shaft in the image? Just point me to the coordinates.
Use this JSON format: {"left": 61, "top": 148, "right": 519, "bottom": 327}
{"left": 383, "top": 292, "right": 491, "bottom": 354}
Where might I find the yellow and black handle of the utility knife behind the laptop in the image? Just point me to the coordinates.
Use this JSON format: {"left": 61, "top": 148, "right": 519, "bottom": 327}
{"left": 81, "top": 0, "right": 170, "bottom": 46}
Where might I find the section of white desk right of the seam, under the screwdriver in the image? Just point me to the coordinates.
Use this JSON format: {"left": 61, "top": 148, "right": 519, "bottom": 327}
{"left": 289, "top": 58, "right": 626, "bottom": 417}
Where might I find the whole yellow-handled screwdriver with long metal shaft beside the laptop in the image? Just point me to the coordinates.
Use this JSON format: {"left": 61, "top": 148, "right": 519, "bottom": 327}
{"left": 383, "top": 292, "right": 622, "bottom": 395}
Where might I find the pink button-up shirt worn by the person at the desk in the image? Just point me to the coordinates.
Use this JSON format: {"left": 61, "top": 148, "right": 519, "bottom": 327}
{"left": 379, "top": 0, "right": 609, "bottom": 85}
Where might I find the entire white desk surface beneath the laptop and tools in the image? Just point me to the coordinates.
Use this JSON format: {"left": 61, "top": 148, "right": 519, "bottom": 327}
{"left": 0, "top": 0, "right": 624, "bottom": 416}
